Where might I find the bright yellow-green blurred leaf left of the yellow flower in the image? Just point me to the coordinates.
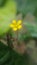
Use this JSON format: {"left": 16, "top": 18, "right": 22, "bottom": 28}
{"left": 0, "top": 0, "right": 16, "bottom": 35}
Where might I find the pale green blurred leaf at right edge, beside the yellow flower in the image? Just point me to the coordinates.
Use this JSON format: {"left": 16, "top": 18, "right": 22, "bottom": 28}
{"left": 25, "top": 22, "right": 37, "bottom": 37}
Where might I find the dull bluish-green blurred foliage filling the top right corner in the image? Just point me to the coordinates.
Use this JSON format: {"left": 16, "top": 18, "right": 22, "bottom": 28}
{"left": 17, "top": 0, "right": 37, "bottom": 15}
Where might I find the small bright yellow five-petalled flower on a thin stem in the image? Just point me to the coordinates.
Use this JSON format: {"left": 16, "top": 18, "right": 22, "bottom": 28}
{"left": 10, "top": 20, "right": 22, "bottom": 31}
